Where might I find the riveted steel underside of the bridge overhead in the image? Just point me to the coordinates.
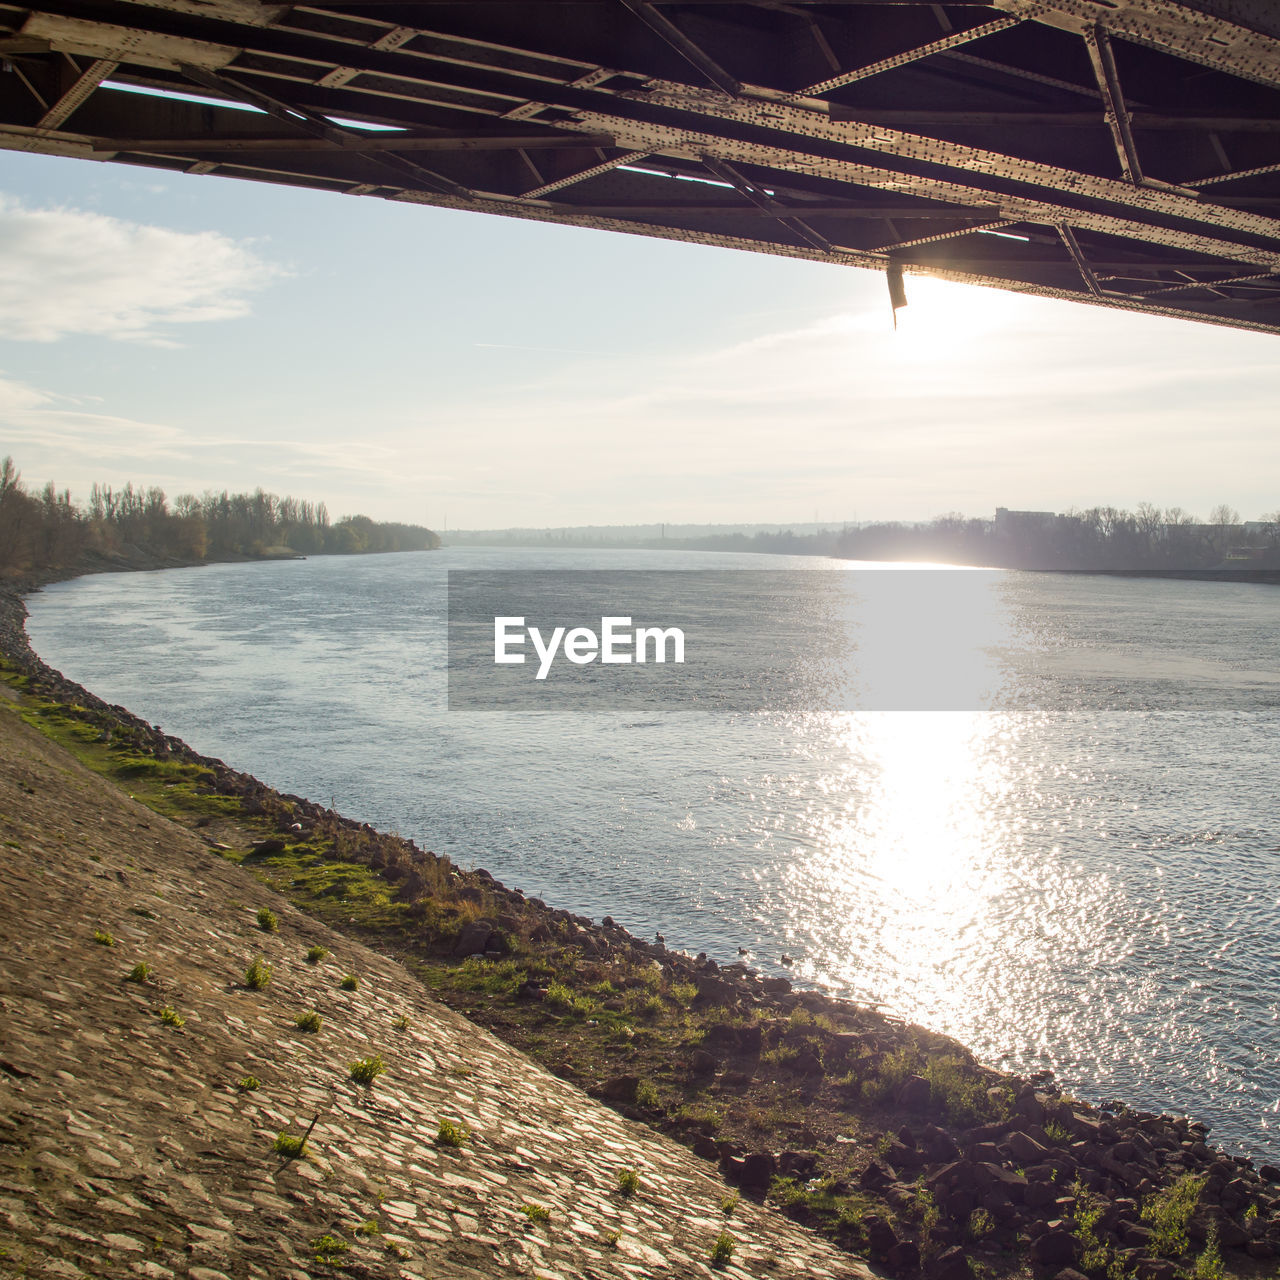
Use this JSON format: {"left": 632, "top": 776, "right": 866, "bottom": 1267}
{"left": 0, "top": 0, "right": 1280, "bottom": 333}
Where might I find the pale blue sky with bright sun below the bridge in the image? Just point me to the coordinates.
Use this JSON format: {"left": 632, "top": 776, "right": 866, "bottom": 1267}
{"left": 0, "top": 103, "right": 1280, "bottom": 529}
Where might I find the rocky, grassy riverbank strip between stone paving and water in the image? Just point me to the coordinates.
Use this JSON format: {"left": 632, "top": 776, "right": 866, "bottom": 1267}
{"left": 0, "top": 583, "right": 1280, "bottom": 1275}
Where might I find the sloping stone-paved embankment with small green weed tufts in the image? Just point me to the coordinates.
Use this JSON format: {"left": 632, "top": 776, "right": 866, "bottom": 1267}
{"left": 0, "top": 704, "right": 870, "bottom": 1280}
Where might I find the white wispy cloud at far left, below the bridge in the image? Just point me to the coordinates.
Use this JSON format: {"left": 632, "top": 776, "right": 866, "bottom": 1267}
{"left": 0, "top": 193, "right": 283, "bottom": 347}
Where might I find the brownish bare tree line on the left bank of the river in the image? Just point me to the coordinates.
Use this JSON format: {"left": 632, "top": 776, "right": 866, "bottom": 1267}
{"left": 0, "top": 457, "right": 440, "bottom": 575}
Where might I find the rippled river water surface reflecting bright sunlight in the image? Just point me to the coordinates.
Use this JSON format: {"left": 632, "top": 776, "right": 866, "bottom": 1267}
{"left": 29, "top": 549, "right": 1280, "bottom": 1158}
